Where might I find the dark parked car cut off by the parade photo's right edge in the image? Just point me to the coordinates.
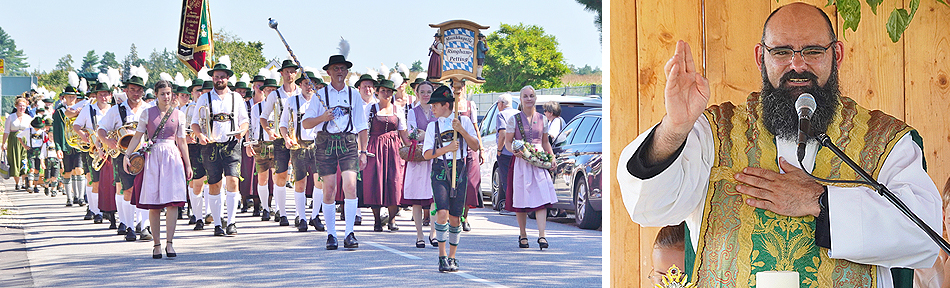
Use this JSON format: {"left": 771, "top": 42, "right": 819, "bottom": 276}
{"left": 551, "top": 109, "right": 603, "bottom": 229}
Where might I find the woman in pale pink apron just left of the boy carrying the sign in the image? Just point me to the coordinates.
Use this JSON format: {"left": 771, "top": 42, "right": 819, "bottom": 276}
{"left": 399, "top": 81, "right": 439, "bottom": 248}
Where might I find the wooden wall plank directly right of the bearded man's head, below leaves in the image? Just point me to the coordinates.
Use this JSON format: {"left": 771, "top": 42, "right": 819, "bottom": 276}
{"left": 838, "top": 1, "right": 908, "bottom": 119}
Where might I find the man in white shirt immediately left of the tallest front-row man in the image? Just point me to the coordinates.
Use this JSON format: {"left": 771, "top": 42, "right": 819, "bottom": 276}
{"left": 280, "top": 71, "right": 326, "bottom": 232}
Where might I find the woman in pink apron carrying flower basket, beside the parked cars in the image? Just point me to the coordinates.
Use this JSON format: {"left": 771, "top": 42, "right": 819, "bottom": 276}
{"left": 505, "top": 86, "right": 557, "bottom": 249}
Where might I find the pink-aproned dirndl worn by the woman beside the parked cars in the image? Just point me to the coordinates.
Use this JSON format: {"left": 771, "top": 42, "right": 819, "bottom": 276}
{"left": 505, "top": 113, "right": 557, "bottom": 212}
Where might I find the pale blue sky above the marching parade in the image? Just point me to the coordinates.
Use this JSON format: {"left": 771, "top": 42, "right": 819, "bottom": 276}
{"left": 0, "top": 0, "right": 602, "bottom": 71}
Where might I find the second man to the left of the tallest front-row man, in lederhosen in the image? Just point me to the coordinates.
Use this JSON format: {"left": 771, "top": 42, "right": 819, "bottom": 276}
{"left": 257, "top": 60, "right": 300, "bottom": 226}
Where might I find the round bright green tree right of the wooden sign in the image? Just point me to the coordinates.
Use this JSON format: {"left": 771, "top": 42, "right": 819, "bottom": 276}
{"left": 483, "top": 23, "right": 570, "bottom": 92}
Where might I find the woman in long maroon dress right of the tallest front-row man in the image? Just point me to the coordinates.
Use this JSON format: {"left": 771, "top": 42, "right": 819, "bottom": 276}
{"left": 363, "top": 79, "right": 409, "bottom": 232}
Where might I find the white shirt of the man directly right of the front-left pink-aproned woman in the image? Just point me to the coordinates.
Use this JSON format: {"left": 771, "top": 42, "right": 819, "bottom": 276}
{"left": 191, "top": 89, "right": 249, "bottom": 142}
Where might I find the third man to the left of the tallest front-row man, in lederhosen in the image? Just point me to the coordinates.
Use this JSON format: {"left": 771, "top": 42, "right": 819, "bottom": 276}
{"left": 244, "top": 75, "right": 280, "bottom": 221}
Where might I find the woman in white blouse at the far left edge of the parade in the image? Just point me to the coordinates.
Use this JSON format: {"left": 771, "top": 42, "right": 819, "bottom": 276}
{"left": 2, "top": 98, "right": 33, "bottom": 190}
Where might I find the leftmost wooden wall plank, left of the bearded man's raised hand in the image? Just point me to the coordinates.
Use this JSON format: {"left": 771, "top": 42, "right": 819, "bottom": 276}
{"left": 604, "top": 0, "right": 641, "bottom": 287}
